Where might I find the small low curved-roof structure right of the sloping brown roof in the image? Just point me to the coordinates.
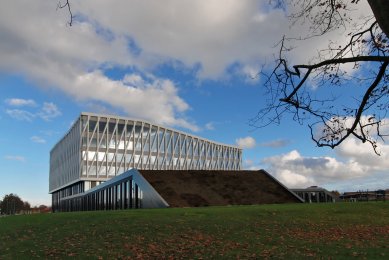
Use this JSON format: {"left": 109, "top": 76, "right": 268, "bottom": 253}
{"left": 290, "top": 186, "right": 337, "bottom": 203}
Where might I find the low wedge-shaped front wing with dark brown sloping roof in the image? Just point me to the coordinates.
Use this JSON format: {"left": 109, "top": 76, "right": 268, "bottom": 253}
{"left": 53, "top": 169, "right": 302, "bottom": 211}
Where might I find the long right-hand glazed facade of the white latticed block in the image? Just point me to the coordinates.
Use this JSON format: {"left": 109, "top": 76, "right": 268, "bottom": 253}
{"left": 81, "top": 115, "right": 241, "bottom": 178}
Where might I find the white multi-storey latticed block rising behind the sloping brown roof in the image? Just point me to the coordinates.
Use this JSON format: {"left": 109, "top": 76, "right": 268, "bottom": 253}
{"left": 49, "top": 113, "right": 242, "bottom": 211}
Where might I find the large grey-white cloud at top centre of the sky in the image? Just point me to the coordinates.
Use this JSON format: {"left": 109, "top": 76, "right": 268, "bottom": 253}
{"left": 73, "top": 0, "right": 287, "bottom": 78}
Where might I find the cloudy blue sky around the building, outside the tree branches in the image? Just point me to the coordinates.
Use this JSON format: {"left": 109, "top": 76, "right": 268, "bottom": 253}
{"left": 0, "top": 0, "right": 389, "bottom": 205}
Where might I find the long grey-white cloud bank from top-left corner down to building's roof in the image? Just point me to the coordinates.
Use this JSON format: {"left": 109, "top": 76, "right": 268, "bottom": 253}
{"left": 0, "top": 0, "right": 199, "bottom": 131}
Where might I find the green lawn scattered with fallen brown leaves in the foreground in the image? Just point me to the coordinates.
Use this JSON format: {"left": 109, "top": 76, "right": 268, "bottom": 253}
{"left": 0, "top": 202, "right": 389, "bottom": 259}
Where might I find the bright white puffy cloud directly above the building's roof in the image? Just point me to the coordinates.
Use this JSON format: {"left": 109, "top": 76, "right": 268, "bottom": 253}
{"left": 71, "top": 71, "right": 199, "bottom": 131}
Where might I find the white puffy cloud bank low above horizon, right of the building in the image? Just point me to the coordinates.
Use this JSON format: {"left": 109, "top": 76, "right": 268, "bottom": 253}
{"left": 262, "top": 146, "right": 388, "bottom": 190}
